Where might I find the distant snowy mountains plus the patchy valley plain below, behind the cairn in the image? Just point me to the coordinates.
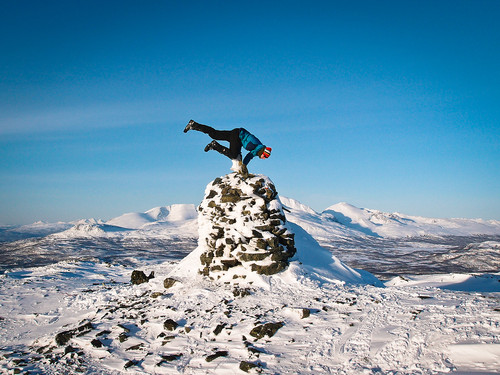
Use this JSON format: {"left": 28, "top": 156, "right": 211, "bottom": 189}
{"left": 0, "top": 200, "right": 500, "bottom": 279}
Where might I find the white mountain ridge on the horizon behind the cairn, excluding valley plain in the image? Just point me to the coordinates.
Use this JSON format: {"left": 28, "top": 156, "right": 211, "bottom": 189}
{"left": 0, "top": 200, "right": 500, "bottom": 242}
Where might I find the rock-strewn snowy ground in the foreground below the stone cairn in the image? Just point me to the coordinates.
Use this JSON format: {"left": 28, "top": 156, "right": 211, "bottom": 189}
{"left": 0, "top": 262, "right": 500, "bottom": 374}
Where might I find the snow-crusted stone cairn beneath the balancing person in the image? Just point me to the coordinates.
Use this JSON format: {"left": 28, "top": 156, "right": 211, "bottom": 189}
{"left": 198, "top": 173, "right": 296, "bottom": 278}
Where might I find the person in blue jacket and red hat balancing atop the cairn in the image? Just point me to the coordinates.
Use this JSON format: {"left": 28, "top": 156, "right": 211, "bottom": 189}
{"left": 184, "top": 120, "right": 272, "bottom": 166}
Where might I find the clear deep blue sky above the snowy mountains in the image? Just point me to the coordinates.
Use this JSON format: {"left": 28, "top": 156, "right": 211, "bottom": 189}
{"left": 0, "top": 0, "right": 500, "bottom": 224}
